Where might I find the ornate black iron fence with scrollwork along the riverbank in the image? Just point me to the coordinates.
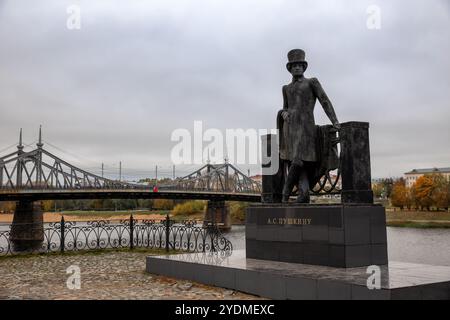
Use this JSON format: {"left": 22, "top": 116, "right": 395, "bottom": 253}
{"left": 0, "top": 216, "right": 233, "bottom": 256}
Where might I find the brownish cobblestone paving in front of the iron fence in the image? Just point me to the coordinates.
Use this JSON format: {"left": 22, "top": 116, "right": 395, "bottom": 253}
{"left": 0, "top": 251, "right": 260, "bottom": 300}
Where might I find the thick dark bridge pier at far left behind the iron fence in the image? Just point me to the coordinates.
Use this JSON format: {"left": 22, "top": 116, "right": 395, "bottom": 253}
{"left": 9, "top": 200, "right": 44, "bottom": 252}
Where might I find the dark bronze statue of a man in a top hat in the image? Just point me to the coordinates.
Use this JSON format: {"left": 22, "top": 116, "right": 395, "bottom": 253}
{"left": 277, "top": 49, "right": 340, "bottom": 203}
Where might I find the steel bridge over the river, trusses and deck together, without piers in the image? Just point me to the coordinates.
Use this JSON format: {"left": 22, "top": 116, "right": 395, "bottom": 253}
{"left": 0, "top": 129, "right": 261, "bottom": 202}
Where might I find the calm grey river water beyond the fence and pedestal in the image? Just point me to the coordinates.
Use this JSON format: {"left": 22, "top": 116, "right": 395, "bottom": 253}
{"left": 0, "top": 223, "right": 450, "bottom": 266}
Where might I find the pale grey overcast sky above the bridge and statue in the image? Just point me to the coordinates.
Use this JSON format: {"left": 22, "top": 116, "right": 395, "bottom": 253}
{"left": 0, "top": 0, "right": 450, "bottom": 177}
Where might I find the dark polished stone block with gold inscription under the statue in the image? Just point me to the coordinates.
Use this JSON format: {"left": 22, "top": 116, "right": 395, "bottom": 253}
{"left": 245, "top": 204, "right": 388, "bottom": 268}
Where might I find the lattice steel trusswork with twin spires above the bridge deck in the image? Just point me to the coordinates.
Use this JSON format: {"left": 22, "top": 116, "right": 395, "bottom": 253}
{"left": 0, "top": 130, "right": 261, "bottom": 193}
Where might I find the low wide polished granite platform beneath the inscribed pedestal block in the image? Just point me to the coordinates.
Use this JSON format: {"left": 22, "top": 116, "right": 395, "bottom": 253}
{"left": 146, "top": 250, "right": 450, "bottom": 300}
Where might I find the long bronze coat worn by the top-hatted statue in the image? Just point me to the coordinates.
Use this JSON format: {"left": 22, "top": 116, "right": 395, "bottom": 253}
{"left": 277, "top": 78, "right": 338, "bottom": 162}
